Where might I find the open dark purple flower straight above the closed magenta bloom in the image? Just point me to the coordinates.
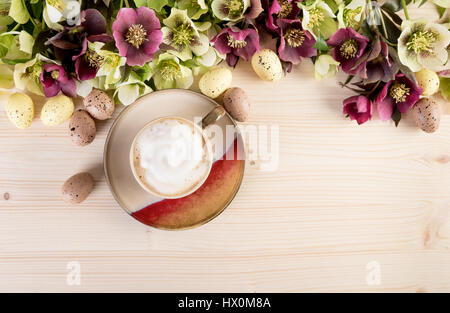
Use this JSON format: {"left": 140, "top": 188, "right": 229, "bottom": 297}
{"left": 327, "top": 27, "right": 369, "bottom": 77}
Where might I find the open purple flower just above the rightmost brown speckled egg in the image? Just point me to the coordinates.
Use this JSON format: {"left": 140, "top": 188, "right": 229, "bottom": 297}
{"left": 376, "top": 74, "right": 422, "bottom": 121}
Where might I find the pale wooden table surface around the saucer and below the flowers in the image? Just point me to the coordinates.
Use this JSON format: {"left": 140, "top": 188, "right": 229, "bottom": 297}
{"left": 0, "top": 6, "right": 450, "bottom": 292}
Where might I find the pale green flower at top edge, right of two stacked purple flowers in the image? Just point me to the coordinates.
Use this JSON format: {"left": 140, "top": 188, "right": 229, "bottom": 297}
{"left": 300, "top": 0, "right": 337, "bottom": 39}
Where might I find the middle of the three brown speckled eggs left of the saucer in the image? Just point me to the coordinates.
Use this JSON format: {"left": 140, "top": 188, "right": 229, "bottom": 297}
{"left": 69, "top": 110, "right": 97, "bottom": 146}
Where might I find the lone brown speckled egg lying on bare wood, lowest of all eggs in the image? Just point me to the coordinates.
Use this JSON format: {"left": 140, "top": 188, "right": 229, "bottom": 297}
{"left": 61, "top": 173, "right": 94, "bottom": 203}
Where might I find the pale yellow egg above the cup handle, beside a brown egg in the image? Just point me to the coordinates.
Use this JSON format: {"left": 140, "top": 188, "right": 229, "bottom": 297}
{"left": 198, "top": 67, "right": 233, "bottom": 99}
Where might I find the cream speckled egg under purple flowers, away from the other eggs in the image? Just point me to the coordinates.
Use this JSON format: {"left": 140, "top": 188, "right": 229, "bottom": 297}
{"left": 252, "top": 49, "right": 283, "bottom": 82}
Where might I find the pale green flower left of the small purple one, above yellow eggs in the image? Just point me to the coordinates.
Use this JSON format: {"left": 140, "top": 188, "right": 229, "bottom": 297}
{"left": 14, "top": 54, "right": 57, "bottom": 96}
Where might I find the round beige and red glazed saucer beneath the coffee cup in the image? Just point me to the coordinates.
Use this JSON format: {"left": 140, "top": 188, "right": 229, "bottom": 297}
{"left": 103, "top": 89, "right": 245, "bottom": 230}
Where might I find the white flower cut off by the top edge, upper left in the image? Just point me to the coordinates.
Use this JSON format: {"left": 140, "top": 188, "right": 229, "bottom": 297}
{"left": 45, "top": 0, "right": 81, "bottom": 25}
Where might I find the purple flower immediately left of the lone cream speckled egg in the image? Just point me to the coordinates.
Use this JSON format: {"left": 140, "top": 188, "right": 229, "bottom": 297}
{"left": 211, "top": 27, "right": 259, "bottom": 66}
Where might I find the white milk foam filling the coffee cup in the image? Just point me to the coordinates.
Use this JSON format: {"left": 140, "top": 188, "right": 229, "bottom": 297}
{"left": 135, "top": 119, "right": 211, "bottom": 196}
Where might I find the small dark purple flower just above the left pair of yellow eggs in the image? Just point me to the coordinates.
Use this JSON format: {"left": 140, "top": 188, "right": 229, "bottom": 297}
{"left": 40, "top": 64, "right": 77, "bottom": 98}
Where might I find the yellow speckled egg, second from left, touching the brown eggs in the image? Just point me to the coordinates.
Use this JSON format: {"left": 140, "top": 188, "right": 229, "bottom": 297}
{"left": 41, "top": 95, "right": 74, "bottom": 126}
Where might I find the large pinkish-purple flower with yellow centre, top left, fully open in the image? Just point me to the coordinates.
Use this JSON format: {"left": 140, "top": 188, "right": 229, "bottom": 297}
{"left": 112, "top": 7, "right": 163, "bottom": 66}
